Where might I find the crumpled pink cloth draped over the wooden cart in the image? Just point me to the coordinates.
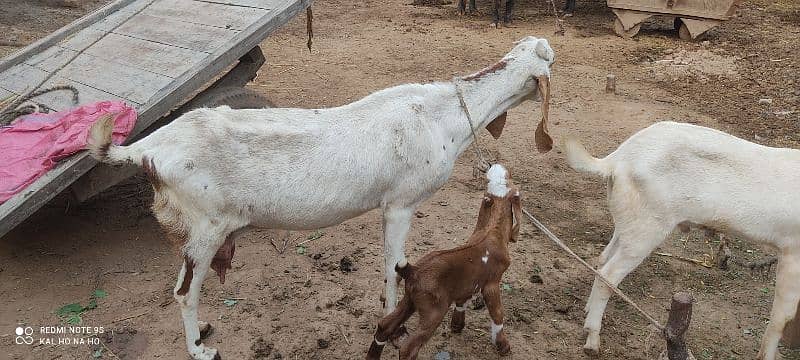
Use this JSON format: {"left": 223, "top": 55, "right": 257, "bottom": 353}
{"left": 0, "top": 101, "right": 136, "bottom": 203}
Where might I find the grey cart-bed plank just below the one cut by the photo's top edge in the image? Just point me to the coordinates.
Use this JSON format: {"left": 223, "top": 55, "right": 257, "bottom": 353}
{"left": 114, "top": 14, "right": 238, "bottom": 53}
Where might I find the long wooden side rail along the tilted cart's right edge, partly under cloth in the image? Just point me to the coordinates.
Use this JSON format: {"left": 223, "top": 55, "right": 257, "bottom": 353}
{"left": 0, "top": 0, "right": 312, "bottom": 236}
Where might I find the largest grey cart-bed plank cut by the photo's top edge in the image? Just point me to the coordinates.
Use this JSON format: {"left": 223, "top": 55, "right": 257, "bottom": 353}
{"left": 142, "top": 0, "right": 268, "bottom": 30}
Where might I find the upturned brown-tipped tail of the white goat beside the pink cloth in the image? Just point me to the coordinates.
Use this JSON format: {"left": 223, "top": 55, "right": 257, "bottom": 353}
{"left": 86, "top": 113, "right": 141, "bottom": 164}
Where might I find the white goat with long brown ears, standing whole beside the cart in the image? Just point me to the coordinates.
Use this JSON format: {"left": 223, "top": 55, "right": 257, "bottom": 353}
{"left": 88, "top": 37, "right": 555, "bottom": 360}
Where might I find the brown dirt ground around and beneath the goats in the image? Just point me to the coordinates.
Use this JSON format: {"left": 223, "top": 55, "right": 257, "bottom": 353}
{"left": 0, "top": 0, "right": 800, "bottom": 360}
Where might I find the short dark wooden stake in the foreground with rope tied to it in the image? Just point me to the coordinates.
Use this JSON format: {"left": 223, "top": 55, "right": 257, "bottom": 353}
{"left": 661, "top": 292, "right": 694, "bottom": 360}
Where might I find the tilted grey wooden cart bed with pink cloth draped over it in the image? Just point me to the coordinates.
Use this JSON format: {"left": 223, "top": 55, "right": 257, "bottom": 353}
{"left": 0, "top": 0, "right": 312, "bottom": 236}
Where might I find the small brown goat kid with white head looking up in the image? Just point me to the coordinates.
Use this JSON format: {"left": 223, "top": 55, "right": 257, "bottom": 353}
{"left": 367, "top": 164, "right": 522, "bottom": 360}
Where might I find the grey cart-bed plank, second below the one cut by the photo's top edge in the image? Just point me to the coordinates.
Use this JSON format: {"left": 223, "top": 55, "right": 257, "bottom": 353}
{"left": 65, "top": 34, "right": 208, "bottom": 78}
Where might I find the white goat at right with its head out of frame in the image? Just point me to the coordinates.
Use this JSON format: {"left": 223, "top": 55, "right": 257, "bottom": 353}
{"left": 565, "top": 122, "right": 800, "bottom": 360}
